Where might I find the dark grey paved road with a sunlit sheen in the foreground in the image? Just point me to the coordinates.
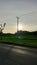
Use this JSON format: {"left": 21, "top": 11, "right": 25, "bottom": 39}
{"left": 0, "top": 43, "right": 37, "bottom": 65}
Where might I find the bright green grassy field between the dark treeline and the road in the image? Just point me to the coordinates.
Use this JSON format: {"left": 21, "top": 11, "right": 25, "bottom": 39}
{"left": 0, "top": 35, "right": 37, "bottom": 47}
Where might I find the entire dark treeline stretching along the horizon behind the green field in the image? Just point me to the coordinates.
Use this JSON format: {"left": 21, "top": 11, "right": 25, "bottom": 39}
{"left": 0, "top": 31, "right": 37, "bottom": 36}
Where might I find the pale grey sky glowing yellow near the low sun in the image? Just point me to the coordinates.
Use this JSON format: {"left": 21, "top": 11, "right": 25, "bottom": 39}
{"left": 0, "top": 0, "right": 37, "bottom": 33}
